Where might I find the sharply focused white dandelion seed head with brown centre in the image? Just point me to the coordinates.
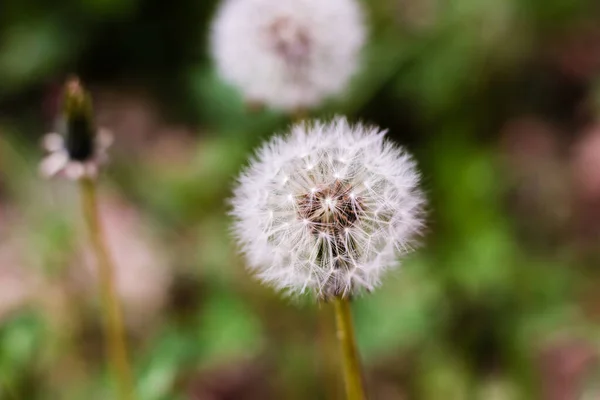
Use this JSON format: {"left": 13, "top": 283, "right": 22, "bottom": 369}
{"left": 232, "top": 118, "right": 425, "bottom": 299}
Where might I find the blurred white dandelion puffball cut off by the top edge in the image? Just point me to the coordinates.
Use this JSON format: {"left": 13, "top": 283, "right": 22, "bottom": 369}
{"left": 211, "top": 0, "right": 366, "bottom": 111}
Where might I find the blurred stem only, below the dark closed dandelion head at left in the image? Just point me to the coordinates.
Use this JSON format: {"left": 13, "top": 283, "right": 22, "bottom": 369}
{"left": 79, "top": 178, "right": 135, "bottom": 400}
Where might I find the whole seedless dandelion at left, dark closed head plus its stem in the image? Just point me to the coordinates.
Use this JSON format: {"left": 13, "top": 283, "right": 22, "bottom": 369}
{"left": 40, "top": 77, "right": 135, "bottom": 400}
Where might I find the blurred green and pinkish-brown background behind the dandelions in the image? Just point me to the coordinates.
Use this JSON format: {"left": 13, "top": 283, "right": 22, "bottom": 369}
{"left": 0, "top": 0, "right": 600, "bottom": 400}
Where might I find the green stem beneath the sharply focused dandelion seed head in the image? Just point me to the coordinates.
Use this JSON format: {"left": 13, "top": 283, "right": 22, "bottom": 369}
{"left": 333, "top": 296, "right": 366, "bottom": 400}
